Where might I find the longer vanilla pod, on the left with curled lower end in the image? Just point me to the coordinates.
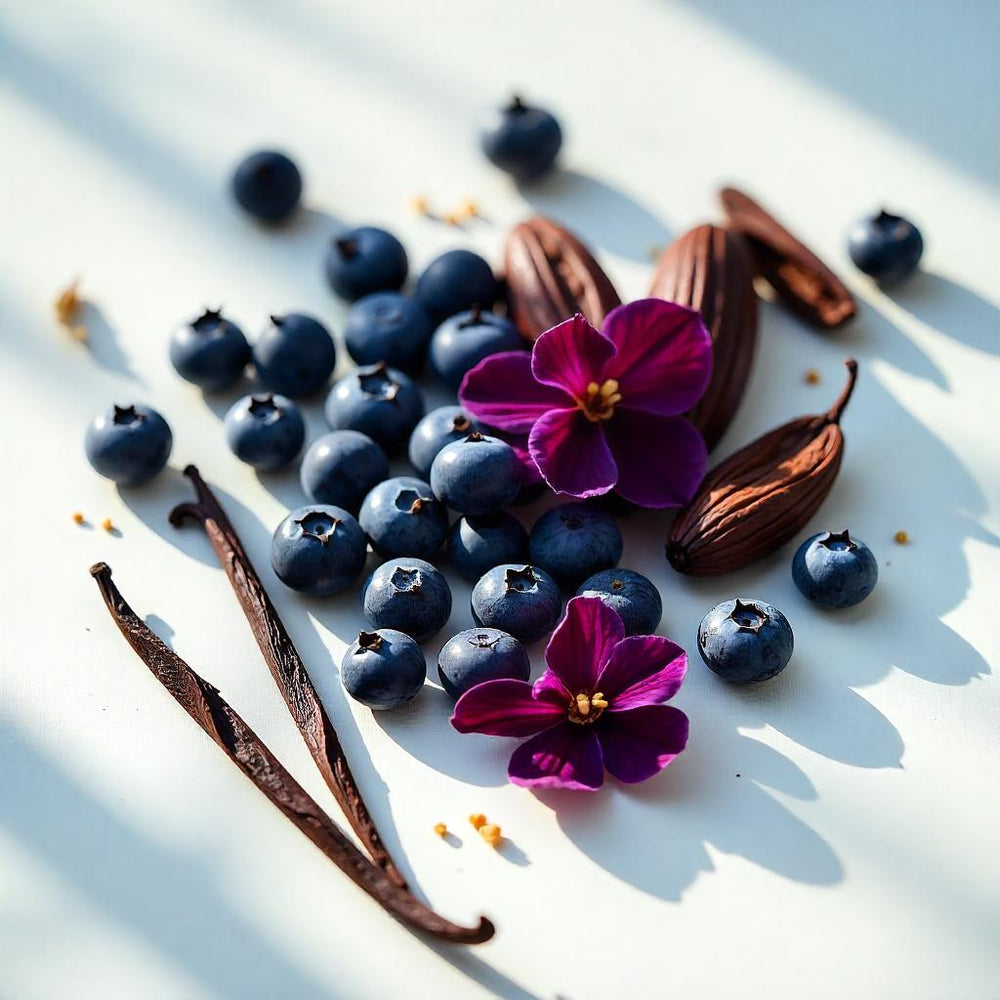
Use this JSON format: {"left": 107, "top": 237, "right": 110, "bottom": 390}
{"left": 90, "top": 564, "right": 494, "bottom": 944}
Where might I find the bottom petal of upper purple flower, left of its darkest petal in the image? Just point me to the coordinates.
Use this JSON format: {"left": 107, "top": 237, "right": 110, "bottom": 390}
{"left": 528, "top": 410, "right": 618, "bottom": 497}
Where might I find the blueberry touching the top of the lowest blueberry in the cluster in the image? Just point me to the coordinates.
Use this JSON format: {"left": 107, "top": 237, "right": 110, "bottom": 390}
{"left": 361, "top": 556, "right": 451, "bottom": 642}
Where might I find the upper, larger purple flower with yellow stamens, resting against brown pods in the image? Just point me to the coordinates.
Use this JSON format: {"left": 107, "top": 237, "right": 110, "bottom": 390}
{"left": 458, "top": 299, "right": 712, "bottom": 507}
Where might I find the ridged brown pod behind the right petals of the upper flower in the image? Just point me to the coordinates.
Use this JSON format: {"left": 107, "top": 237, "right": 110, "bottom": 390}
{"left": 649, "top": 225, "right": 757, "bottom": 449}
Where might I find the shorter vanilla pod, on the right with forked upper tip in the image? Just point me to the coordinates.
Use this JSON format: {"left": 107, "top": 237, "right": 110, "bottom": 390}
{"left": 170, "top": 465, "right": 406, "bottom": 888}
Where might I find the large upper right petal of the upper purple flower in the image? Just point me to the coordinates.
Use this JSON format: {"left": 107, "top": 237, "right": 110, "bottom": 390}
{"left": 596, "top": 299, "right": 712, "bottom": 417}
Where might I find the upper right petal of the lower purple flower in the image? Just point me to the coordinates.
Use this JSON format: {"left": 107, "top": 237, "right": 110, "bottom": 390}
{"left": 597, "top": 635, "right": 687, "bottom": 712}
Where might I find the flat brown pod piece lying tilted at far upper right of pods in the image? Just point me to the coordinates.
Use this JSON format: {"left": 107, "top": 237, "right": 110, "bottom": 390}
{"left": 719, "top": 188, "right": 857, "bottom": 330}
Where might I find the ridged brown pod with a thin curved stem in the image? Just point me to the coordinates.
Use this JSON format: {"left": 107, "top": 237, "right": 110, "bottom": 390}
{"left": 667, "top": 358, "right": 858, "bottom": 576}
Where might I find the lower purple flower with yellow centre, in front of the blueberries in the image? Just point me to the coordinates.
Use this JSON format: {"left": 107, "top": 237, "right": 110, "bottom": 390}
{"left": 451, "top": 597, "right": 688, "bottom": 792}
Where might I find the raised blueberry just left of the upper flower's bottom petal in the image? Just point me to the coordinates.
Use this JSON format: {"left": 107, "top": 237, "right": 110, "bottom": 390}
{"left": 431, "top": 431, "right": 522, "bottom": 514}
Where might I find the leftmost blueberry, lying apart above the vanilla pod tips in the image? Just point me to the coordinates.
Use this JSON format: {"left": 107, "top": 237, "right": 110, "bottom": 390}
{"left": 83, "top": 404, "right": 174, "bottom": 486}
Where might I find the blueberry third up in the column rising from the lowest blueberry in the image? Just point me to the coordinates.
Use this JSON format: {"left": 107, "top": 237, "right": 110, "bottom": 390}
{"left": 358, "top": 476, "right": 448, "bottom": 559}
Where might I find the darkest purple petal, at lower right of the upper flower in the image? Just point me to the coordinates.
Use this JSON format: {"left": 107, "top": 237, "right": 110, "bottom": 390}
{"left": 604, "top": 407, "right": 708, "bottom": 507}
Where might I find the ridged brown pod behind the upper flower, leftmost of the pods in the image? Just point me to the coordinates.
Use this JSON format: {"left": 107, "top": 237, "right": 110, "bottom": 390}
{"left": 504, "top": 215, "right": 621, "bottom": 342}
